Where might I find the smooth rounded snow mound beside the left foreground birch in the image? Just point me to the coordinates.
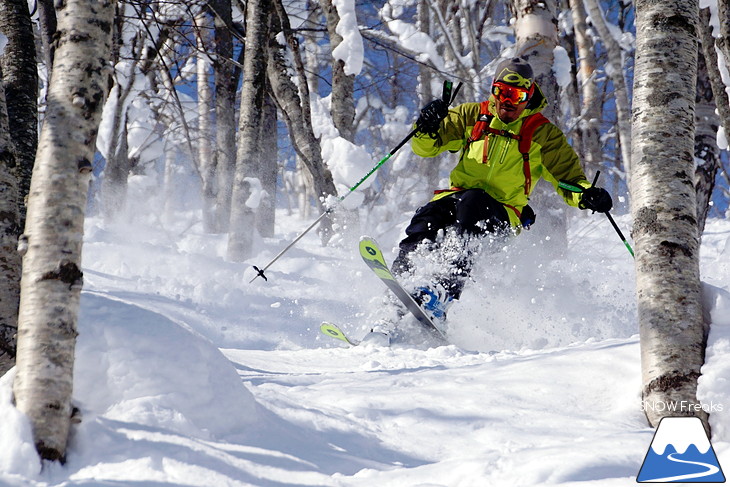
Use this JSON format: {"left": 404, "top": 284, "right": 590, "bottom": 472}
{"left": 74, "top": 293, "right": 256, "bottom": 439}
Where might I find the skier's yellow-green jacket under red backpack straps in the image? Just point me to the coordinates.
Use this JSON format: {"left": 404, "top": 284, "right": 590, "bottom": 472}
{"left": 411, "top": 88, "right": 590, "bottom": 227}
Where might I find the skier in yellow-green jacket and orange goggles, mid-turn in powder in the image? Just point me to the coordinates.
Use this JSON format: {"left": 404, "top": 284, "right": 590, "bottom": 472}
{"left": 366, "top": 57, "right": 612, "bottom": 342}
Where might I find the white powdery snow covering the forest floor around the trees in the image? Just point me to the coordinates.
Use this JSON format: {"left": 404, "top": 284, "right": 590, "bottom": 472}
{"left": 0, "top": 203, "right": 730, "bottom": 487}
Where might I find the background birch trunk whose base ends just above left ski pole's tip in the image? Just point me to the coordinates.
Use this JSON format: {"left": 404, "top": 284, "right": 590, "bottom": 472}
{"left": 227, "top": 0, "right": 273, "bottom": 262}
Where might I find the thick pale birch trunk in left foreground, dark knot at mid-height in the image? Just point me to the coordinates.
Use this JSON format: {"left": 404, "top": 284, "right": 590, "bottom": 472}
{"left": 14, "top": 0, "right": 114, "bottom": 460}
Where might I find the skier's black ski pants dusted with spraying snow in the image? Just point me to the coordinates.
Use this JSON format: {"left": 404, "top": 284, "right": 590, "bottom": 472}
{"left": 393, "top": 189, "right": 510, "bottom": 299}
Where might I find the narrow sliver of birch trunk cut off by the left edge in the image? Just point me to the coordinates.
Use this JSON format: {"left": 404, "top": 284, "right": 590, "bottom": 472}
{"left": 0, "top": 66, "right": 20, "bottom": 376}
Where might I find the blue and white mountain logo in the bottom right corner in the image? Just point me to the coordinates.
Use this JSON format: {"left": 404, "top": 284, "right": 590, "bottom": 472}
{"left": 636, "top": 416, "right": 725, "bottom": 483}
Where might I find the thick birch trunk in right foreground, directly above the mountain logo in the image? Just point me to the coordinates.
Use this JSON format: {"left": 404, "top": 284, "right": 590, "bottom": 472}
{"left": 631, "top": 0, "right": 707, "bottom": 426}
